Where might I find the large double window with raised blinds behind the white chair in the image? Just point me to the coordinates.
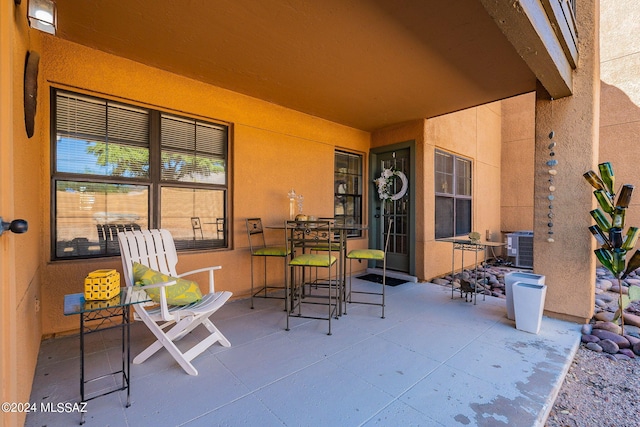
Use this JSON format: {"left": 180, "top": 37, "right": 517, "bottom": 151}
{"left": 51, "top": 89, "right": 229, "bottom": 259}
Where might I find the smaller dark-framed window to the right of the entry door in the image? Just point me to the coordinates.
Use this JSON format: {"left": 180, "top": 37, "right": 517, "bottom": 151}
{"left": 434, "top": 150, "right": 472, "bottom": 239}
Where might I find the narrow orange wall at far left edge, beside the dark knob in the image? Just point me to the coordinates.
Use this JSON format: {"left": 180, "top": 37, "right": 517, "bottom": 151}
{"left": 0, "top": 2, "right": 42, "bottom": 426}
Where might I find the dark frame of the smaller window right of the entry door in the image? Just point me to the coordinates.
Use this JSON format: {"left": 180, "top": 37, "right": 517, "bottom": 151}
{"left": 433, "top": 148, "right": 473, "bottom": 239}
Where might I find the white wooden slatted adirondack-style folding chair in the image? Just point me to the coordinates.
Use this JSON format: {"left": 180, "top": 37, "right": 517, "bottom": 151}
{"left": 118, "top": 230, "right": 232, "bottom": 375}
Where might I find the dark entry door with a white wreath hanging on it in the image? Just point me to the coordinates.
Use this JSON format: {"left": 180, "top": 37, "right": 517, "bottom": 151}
{"left": 369, "top": 148, "right": 414, "bottom": 273}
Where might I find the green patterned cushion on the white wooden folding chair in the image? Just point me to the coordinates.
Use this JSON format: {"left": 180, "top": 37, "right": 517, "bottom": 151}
{"left": 133, "top": 262, "right": 202, "bottom": 305}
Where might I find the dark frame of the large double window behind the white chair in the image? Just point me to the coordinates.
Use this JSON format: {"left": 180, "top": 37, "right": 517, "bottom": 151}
{"left": 50, "top": 87, "right": 233, "bottom": 261}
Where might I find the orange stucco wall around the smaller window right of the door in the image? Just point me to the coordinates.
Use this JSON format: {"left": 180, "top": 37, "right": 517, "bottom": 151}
{"left": 372, "top": 102, "right": 502, "bottom": 280}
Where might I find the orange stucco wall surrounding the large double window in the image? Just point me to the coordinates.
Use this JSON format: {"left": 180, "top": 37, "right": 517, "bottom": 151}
{"left": 39, "top": 37, "right": 370, "bottom": 335}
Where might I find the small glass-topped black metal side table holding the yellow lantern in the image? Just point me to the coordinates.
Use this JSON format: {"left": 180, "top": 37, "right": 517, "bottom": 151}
{"left": 64, "top": 287, "right": 149, "bottom": 424}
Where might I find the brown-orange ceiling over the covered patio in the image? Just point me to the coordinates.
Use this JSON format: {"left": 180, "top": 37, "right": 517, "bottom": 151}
{"left": 57, "top": 0, "right": 536, "bottom": 131}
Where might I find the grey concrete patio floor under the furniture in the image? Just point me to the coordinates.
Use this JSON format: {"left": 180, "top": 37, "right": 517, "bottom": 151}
{"left": 26, "top": 279, "right": 580, "bottom": 427}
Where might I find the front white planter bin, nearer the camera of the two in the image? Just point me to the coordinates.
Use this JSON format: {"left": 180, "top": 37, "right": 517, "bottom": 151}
{"left": 511, "top": 282, "right": 547, "bottom": 334}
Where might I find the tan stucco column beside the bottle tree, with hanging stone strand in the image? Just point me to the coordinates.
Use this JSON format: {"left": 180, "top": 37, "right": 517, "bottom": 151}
{"left": 534, "top": 0, "right": 600, "bottom": 322}
